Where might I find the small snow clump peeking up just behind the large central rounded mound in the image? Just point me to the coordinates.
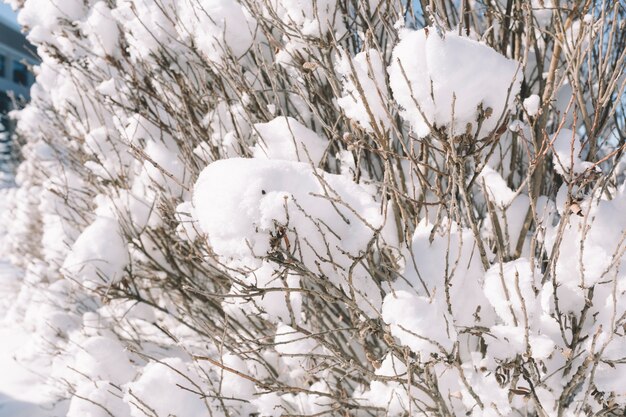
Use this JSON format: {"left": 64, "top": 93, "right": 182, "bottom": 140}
{"left": 252, "top": 116, "right": 328, "bottom": 166}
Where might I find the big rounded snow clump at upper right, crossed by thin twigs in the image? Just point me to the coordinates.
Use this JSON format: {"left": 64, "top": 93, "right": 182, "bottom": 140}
{"left": 389, "top": 28, "right": 522, "bottom": 137}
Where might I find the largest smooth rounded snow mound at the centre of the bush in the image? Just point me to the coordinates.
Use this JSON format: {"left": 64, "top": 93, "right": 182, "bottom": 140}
{"left": 193, "top": 158, "right": 383, "bottom": 270}
